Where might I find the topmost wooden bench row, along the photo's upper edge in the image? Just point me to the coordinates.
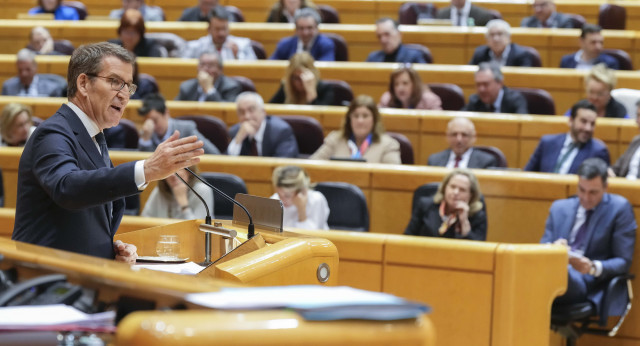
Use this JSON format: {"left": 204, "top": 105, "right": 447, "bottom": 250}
{"left": 0, "top": 0, "right": 640, "bottom": 29}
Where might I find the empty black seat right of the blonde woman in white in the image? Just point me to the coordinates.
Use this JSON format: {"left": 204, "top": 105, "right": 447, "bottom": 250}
{"left": 315, "top": 182, "right": 369, "bottom": 232}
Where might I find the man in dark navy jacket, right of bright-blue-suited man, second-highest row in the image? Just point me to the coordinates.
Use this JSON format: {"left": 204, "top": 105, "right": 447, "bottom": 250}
{"left": 367, "top": 18, "right": 427, "bottom": 64}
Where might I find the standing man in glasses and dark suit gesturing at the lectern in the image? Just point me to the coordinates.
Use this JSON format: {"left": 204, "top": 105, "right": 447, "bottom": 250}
{"left": 12, "top": 42, "right": 203, "bottom": 263}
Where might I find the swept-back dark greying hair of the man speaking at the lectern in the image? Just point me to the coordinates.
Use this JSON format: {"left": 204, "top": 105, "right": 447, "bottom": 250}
{"left": 67, "top": 42, "right": 135, "bottom": 99}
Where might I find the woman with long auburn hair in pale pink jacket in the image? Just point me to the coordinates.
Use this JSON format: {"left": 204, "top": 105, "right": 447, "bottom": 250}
{"left": 378, "top": 66, "right": 442, "bottom": 109}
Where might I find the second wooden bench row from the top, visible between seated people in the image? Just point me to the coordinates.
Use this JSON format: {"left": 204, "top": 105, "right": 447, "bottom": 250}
{"left": 0, "top": 20, "right": 640, "bottom": 67}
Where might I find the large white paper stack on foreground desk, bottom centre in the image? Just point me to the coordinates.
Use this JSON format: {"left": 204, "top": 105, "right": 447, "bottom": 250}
{"left": 186, "top": 285, "right": 430, "bottom": 321}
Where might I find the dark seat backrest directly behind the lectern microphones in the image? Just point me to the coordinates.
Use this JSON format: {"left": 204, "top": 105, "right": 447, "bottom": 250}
{"left": 201, "top": 172, "right": 248, "bottom": 220}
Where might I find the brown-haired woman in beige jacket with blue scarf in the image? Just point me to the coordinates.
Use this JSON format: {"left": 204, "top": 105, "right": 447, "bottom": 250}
{"left": 309, "top": 95, "right": 401, "bottom": 164}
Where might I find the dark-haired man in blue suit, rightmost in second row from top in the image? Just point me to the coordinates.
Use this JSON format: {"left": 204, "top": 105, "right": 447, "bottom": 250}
{"left": 560, "top": 24, "right": 620, "bottom": 70}
